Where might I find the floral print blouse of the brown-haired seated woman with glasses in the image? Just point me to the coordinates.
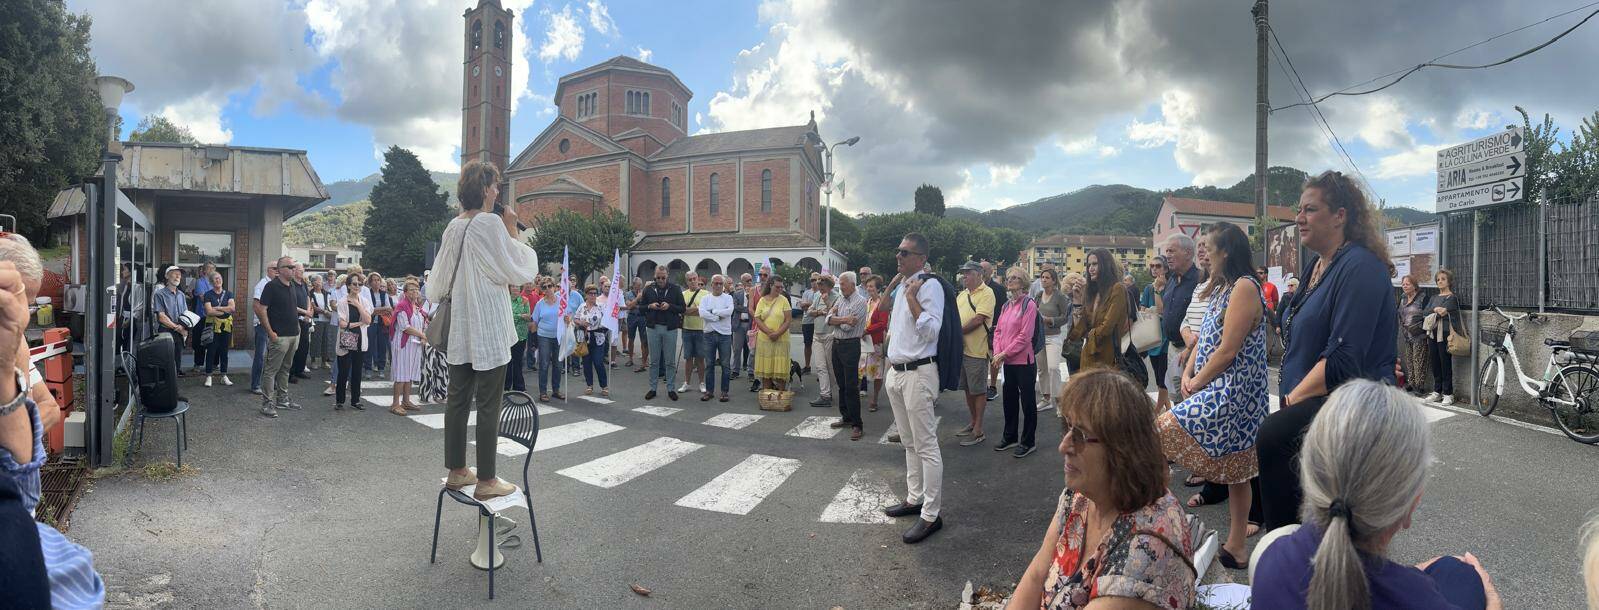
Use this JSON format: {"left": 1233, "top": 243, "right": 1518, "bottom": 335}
{"left": 1039, "top": 490, "right": 1194, "bottom": 610}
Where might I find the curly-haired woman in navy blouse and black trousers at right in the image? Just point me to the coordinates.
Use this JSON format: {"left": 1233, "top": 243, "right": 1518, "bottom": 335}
{"left": 1255, "top": 171, "right": 1399, "bottom": 532}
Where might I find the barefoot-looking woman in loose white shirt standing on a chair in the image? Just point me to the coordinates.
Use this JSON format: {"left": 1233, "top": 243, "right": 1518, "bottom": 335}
{"left": 427, "top": 162, "right": 539, "bottom": 500}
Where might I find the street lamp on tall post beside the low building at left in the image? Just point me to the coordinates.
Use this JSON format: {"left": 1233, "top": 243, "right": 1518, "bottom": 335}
{"left": 83, "top": 75, "right": 134, "bottom": 468}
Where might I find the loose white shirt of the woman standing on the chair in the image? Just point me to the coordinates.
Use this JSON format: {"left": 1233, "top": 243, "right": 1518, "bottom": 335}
{"left": 427, "top": 213, "right": 539, "bottom": 371}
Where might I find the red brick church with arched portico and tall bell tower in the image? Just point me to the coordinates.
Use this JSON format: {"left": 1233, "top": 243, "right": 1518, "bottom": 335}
{"left": 461, "top": 0, "right": 844, "bottom": 280}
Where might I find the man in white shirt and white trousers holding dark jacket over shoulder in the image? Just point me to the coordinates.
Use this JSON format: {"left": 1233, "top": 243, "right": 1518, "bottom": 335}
{"left": 883, "top": 234, "right": 943, "bottom": 544}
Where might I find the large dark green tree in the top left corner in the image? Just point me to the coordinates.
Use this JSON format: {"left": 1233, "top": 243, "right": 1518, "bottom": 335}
{"left": 0, "top": 0, "right": 109, "bottom": 245}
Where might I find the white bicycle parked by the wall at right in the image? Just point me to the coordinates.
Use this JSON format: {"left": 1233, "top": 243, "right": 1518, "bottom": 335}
{"left": 1476, "top": 307, "right": 1599, "bottom": 445}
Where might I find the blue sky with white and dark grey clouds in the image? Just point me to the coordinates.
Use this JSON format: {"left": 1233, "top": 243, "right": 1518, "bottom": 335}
{"left": 67, "top": 0, "right": 1599, "bottom": 213}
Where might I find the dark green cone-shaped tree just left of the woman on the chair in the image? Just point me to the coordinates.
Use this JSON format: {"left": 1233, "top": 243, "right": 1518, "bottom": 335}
{"left": 361, "top": 146, "right": 449, "bottom": 275}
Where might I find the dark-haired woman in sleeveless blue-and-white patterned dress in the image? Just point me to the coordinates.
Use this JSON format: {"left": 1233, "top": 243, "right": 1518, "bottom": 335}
{"left": 1156, "top": 223, "right": 1268, "bottom": 570}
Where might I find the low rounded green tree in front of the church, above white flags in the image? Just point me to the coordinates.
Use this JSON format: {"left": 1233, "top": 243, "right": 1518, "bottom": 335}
{"left": 528, "top": 207, "right": 633, "bottom": 277}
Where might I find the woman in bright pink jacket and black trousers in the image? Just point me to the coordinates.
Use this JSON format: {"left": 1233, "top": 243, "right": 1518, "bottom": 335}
{"left": 988, "top": 267, "right": 1038, "bottom": 458}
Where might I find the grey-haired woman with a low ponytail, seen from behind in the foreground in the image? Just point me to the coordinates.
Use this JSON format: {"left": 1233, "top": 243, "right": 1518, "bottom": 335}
{"left": 1250, "top": 381, "right": 1501, "bottom": 610}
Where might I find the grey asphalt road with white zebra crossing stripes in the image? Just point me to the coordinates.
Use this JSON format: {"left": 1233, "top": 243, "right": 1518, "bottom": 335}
{"left": 69, "top": 347, "right": 1599, "bottom": 608}
